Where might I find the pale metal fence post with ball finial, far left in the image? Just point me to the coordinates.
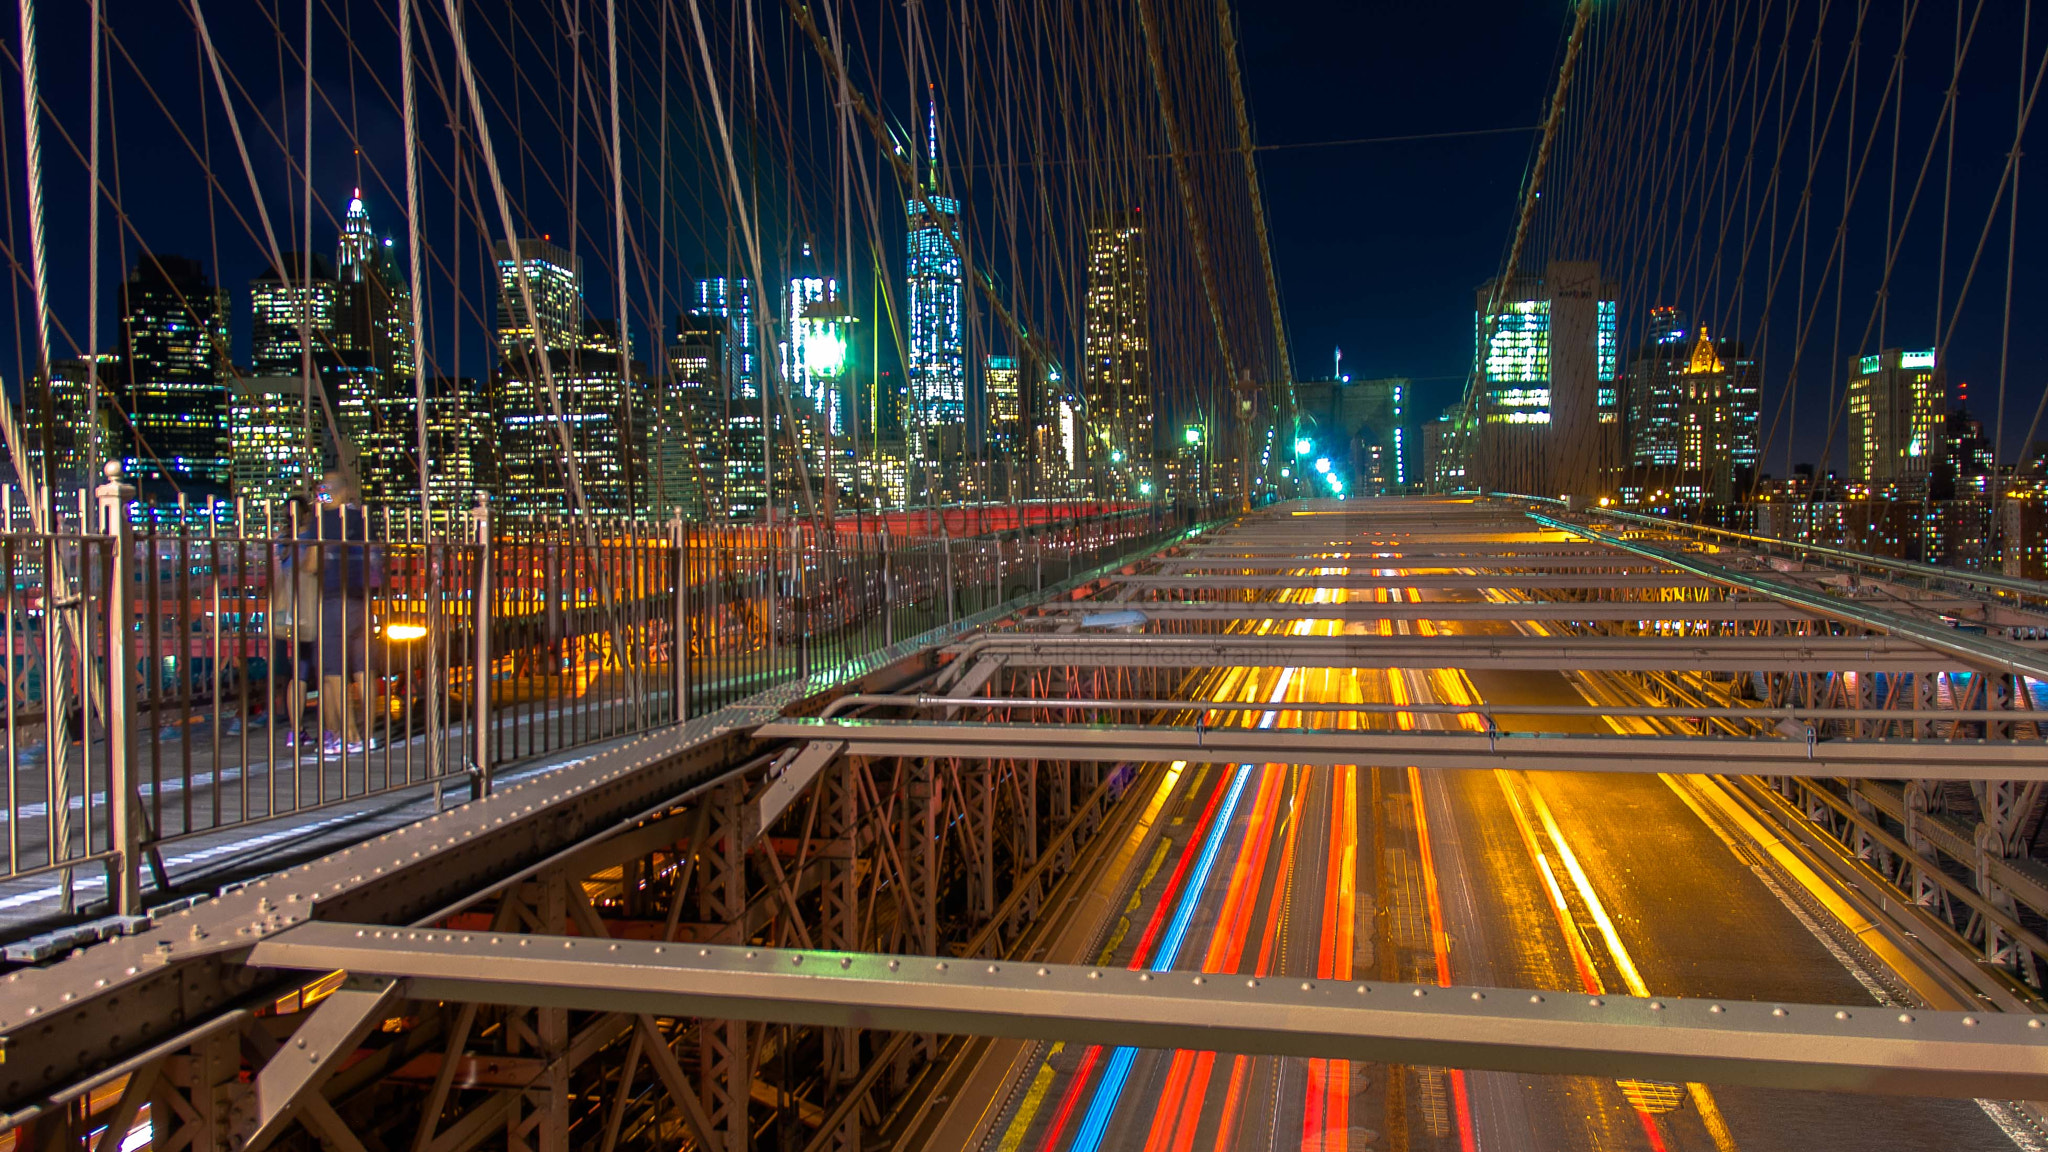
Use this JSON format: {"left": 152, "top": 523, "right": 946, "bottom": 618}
{"left": 95, "top": 461, "right": 141, "bottom": 916}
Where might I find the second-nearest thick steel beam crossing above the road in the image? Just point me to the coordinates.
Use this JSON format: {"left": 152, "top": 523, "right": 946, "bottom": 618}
{"left": 754, "top": 705, "right": 2048, "bottom": 781}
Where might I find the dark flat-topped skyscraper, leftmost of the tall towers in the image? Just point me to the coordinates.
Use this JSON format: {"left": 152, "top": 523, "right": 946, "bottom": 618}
{"left": 121, "top": 254, "right": 233, "bottom": 484}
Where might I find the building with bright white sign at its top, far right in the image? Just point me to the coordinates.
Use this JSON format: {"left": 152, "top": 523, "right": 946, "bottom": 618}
{"left": 1849, "top": 348, "right": 1948, "bottom": 487}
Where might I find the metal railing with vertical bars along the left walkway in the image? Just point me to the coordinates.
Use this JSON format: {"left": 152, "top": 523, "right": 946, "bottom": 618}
{"left": 0, "top": 476, "right": 1221, "bottom": 916}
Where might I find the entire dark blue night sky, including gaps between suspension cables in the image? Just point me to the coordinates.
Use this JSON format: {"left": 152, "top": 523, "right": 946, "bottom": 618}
{"left": 16, "top": 0, "right": 2048, "bottom": 474}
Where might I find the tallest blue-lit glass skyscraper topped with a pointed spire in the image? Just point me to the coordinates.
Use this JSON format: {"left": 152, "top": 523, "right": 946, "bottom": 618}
{"left": 903, "top": 102, "right": 967, "bottom": 467}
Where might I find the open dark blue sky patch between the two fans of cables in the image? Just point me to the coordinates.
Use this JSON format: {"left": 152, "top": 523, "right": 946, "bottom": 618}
{"left": 1239, "top": 2, "right": 1569, "bottom": 420}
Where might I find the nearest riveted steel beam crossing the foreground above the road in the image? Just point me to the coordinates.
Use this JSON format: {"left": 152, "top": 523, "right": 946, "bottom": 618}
{"left": 250, "top": 922, "right": 2048, "bottom": 1099}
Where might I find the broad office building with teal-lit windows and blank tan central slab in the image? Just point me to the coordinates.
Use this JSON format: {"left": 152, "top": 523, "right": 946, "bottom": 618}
{"left": 1470, "top": 260, "right": 1622, "bottom": 494}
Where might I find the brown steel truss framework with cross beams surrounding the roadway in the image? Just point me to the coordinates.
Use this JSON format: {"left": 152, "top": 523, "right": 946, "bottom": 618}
{"left": 0, "top": 502, "right": 2048, "bottom": 1152}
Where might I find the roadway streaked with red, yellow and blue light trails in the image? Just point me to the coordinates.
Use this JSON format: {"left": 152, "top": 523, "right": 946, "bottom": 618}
{"left": 920, "top": 504, "right": 2034, "bottom": 1152}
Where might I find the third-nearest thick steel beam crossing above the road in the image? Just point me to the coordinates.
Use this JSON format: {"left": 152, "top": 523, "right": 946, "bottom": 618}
{"left": 948, "top": 633, "right": 1964, "bottom": 672}
